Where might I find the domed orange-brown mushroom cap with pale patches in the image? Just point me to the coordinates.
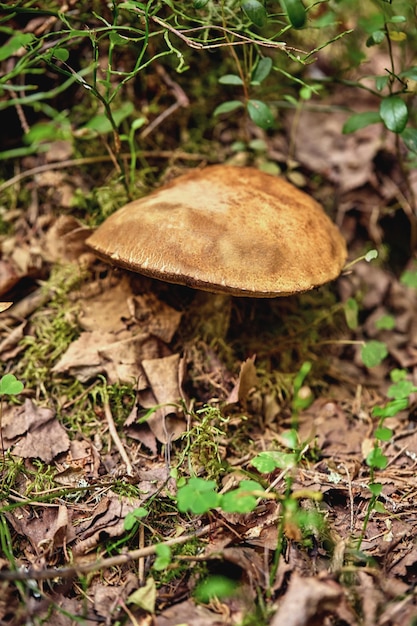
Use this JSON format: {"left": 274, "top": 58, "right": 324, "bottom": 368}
{"left": 87, "top": 165, "right": 346, "bottom": 298}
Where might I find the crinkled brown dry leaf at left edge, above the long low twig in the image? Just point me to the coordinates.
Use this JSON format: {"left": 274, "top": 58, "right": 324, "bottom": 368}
{"left": 3, "top": 399, "right": 70, "bottom": 463}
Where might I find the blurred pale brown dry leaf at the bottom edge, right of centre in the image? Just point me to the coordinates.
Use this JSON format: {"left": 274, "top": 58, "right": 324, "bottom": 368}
{"left": 270, "top": 572, "right": 355, "bottom": 626}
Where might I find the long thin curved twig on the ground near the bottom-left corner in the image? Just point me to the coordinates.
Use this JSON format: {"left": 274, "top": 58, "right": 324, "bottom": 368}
{"left": 0, "top": 524, "right": 214, "bottom": 581}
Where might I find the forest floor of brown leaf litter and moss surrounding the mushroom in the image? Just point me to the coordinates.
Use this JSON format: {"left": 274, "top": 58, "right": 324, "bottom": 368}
{"left": 0, "top": 6, "right": 417, "bottom": 626}
